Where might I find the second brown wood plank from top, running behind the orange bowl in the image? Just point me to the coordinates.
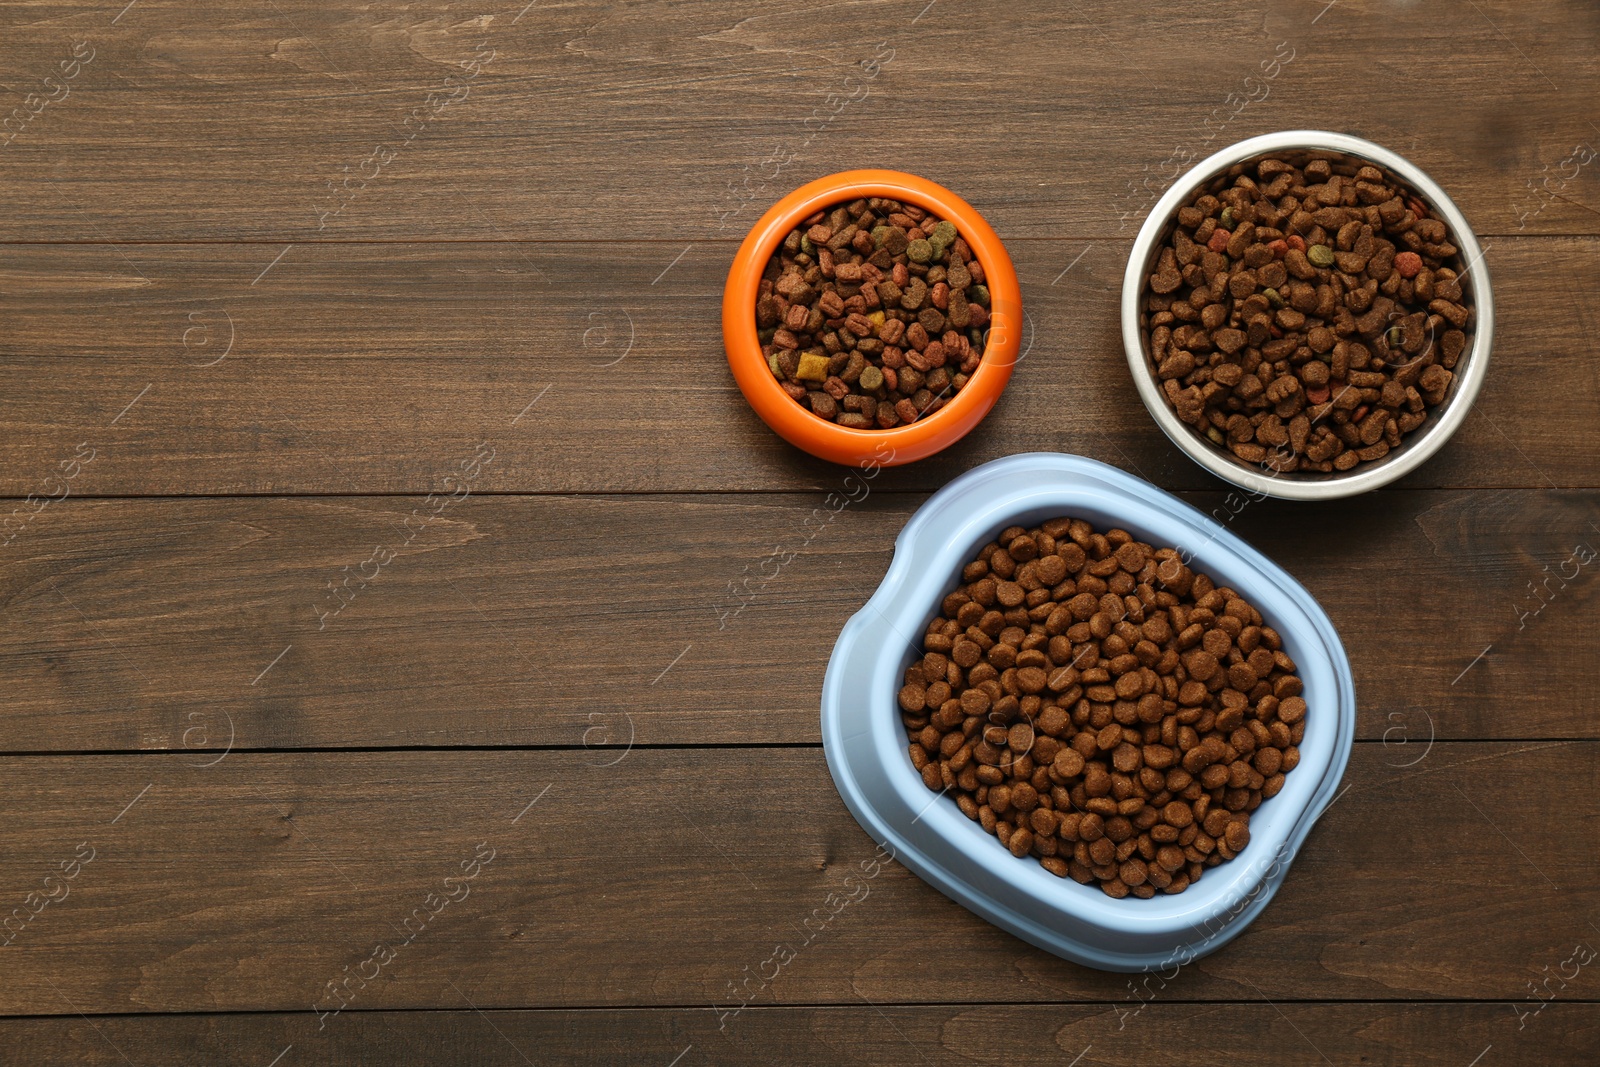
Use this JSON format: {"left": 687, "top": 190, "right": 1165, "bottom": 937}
{"left": 0, "top": 238, "right": 1600, "bottom": 496}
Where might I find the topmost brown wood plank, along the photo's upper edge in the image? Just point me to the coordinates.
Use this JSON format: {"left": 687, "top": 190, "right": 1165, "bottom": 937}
{"left": 0, "top": 0, "right": 1600, "bottom": 243}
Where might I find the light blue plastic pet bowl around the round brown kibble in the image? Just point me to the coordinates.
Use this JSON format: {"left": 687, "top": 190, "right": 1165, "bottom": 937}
{"left": 822, "top": 453, "right": 1355, "bottom": 971}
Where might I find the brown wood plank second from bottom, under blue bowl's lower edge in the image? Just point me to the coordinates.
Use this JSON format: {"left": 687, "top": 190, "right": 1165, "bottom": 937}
{"left": 0, "top": 742, "right": 1600, "bottom": 1017}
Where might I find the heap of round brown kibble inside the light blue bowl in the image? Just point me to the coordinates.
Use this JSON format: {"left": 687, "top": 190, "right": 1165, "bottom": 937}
{"left": 899, "top": 518, "right": 1306, "bottom": 897}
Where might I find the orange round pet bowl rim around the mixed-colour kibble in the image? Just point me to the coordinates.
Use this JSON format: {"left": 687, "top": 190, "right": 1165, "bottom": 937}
{"left": 722, "top": 170, "right": 1022, "bottom": 467}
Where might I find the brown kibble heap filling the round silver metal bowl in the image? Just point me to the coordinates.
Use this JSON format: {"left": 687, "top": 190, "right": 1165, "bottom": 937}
{"left": 1144, "top": 157, "right": 1472, "bottom": 472}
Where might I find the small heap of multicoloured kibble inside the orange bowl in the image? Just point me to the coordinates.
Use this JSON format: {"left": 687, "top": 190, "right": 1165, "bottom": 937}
{"left": 755, "top": 197, "right": 989, "bottom": 430}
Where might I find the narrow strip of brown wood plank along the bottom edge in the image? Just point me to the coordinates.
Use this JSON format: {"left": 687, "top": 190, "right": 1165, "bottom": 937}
{"left": 0, "top": 1004, "right": 1600, "bottom": 1067}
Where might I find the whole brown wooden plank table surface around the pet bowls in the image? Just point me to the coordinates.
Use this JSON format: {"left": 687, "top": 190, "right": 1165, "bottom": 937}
{"left": 0, "top": 0, "right": 1600, "bottom": 1067}
